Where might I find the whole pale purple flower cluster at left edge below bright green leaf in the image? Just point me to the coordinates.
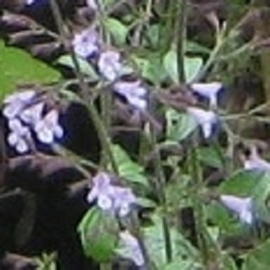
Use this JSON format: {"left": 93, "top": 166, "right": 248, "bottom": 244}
{"left": 3, "top": 90, "right": 64, "bottom": 154}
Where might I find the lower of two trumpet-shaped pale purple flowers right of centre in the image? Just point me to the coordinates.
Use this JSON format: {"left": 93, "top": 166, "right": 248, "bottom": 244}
{"left": 187, "top": 107, "right": 218, "bottom": 139}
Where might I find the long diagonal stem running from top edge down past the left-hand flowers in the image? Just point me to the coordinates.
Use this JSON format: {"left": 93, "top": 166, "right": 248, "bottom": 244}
{"left": 50, "top": 0, "right": 118, "bottom": 173}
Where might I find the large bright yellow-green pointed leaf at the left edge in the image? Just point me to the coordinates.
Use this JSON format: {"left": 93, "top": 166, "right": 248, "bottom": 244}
{"left": 0, "top": 41, "right": 60, "bottom": 100}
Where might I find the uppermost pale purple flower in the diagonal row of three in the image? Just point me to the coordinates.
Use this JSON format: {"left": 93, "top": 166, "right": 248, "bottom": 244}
{"left": 72, "top": 27, "right": 100, "bottom": 58}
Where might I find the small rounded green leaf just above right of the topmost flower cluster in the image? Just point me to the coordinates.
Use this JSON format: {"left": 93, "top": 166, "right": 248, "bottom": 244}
{"left": 104, "top": 18, "right": 128, "bottom": 45}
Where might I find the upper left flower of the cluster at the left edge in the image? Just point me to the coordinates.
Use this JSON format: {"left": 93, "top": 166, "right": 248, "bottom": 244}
{"left": 3, "top": 90, "right": 35, "bottom": 119}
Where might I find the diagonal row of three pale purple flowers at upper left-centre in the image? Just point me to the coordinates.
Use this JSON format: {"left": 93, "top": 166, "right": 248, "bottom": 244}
{"left": 72, "top": 18, "right": 147, "bottom": 110}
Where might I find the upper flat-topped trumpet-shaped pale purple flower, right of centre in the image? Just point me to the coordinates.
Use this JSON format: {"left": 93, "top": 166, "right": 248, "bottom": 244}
{"left": 190, "top": 82, "right": 222, "bottom": 106}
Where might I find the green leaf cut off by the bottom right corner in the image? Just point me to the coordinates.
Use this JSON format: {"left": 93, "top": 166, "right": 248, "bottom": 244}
{"left": 241, "top": 239, "right": 270, "bottom": 270}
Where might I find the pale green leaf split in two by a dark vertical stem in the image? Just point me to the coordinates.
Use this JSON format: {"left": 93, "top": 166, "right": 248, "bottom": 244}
{"left": 163, "top": 50, "right": 203, "bottom": 84}
